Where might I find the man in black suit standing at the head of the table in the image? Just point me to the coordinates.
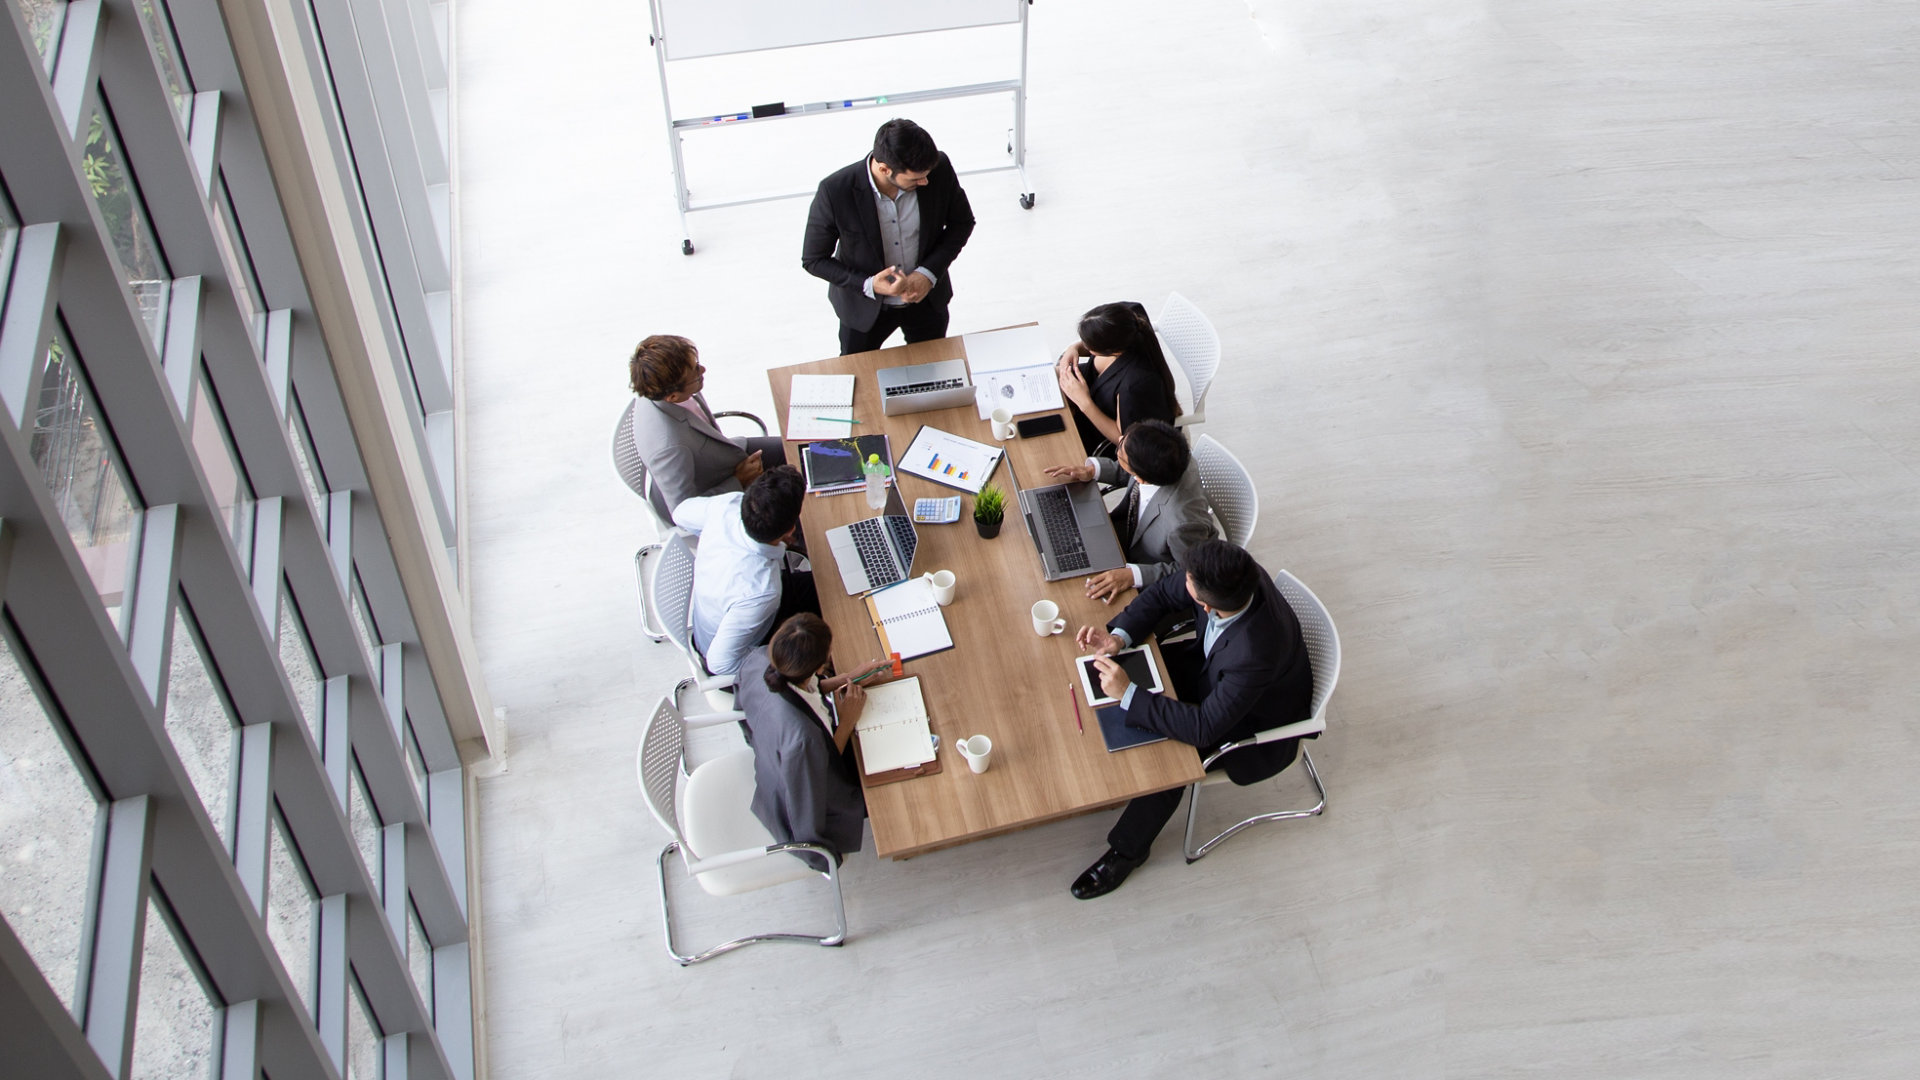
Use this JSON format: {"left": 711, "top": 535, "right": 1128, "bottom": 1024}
{"left": 801, "top": 119, "right": 973, "bottom": 356}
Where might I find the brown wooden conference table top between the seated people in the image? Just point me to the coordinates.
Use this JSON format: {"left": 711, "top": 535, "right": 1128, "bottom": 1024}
{"left": 768, "top": 328, "right": 1202, "bottom": 859}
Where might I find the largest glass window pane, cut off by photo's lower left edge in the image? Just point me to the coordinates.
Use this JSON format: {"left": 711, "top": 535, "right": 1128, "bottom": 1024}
{"left": 0, "top": 636, "right": 98, "bottom": 1009}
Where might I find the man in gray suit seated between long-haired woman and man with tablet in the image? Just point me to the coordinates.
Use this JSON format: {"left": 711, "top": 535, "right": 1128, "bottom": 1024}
{"left": 1046, "top": 421, "right": 1213, "bottom": 603}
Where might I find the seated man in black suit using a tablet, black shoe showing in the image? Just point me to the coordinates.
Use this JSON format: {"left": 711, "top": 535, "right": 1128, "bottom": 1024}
{"left": 1071, "top": 540, "right": 1313, "bottom": 899}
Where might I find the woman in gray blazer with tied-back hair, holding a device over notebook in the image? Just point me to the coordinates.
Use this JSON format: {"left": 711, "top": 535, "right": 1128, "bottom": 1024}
{"left": 733, "top": 613, "right": 887, "bottom": 872}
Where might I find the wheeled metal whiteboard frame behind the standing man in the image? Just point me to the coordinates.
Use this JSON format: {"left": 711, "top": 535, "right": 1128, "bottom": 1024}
{"left": 647, "top": 0, "right": 1035, "bottom": 256}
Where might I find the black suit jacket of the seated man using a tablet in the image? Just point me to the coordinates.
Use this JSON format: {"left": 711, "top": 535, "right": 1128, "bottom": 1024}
{"left": 1108, "top": 571, "right": 1313, "bottom": 784}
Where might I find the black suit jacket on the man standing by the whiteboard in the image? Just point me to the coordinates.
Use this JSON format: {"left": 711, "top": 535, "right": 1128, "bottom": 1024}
{"left": 801, "top": 154, "right": 973, "bottom": 332}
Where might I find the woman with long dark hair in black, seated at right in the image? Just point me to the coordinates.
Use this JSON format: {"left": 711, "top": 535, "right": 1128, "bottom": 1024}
{"left": 1054, "top": 300, "right": 1181, "bottom": 457}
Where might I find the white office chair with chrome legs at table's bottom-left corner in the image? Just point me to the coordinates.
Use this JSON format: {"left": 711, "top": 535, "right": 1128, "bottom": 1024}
{"left": 636, "top": 680, "right": 847, "bottom": 967}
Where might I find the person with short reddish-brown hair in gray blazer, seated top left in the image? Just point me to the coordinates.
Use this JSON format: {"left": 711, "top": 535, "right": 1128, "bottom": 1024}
{"left": 628, "top": 334, "right": 787, "bottom": 521}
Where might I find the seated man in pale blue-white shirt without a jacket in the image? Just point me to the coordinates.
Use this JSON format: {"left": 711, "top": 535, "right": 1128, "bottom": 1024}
{"left": 674, "top": 465, "right": 820, "bottom": 675}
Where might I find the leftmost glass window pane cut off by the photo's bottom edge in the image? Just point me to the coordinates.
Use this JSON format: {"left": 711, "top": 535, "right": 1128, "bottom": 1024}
{"left": 129, "top": 899, "right": 221, "bottom": 1080}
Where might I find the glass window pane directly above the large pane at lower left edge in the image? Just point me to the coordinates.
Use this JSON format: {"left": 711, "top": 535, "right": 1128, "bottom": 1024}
{"left": 29, "top": 336, "right": 138, "bottom": 623}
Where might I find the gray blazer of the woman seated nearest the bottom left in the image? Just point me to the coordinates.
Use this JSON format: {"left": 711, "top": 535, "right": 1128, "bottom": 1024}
{"left": 733, "top": 646, "right": 866, "bottom": 872}
